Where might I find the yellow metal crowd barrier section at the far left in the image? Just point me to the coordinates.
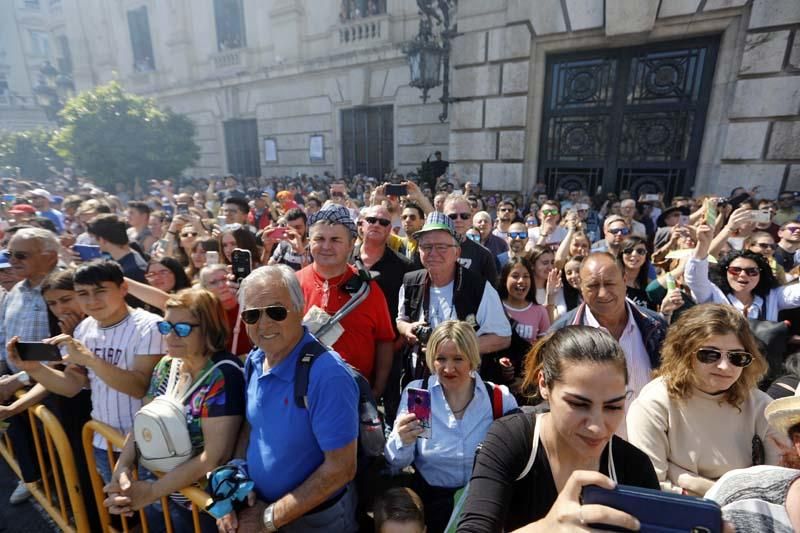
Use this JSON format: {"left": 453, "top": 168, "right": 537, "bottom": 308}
{"left": 0, "top": 400, "right": 90, "bottom": 533}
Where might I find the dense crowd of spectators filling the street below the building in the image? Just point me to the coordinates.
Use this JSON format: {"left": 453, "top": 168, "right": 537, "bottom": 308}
{"left": 0, "top": 174, "right": 800, "bottom": 533}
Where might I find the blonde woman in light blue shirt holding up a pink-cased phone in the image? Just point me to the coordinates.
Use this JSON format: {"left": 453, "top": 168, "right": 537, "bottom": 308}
{"left": 385, "top": 320, "right": 517, "bottom": 533}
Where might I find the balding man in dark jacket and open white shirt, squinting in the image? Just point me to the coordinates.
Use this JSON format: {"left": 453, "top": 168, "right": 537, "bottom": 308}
{"left": 550, "top": 252, "right": 667, "bottom": 402}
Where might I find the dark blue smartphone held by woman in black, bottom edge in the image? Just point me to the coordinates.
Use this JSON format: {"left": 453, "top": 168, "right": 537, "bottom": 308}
{"left": 581, "top": 485, "right": 722, "bottom": 533}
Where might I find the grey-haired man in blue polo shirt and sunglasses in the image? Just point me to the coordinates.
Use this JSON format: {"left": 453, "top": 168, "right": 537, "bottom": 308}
{"left": 218, "top": 265, "right": 358, "bottom": 533}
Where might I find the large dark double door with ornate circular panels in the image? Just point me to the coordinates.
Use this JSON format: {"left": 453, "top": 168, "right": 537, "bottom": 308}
{"left": 539, "top": 38, "right": 719, "bottom": 199}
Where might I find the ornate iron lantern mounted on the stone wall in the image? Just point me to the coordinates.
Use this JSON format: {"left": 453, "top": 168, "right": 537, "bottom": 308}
{"left": 403, "top": 0, "right": 457, "bottom": 122}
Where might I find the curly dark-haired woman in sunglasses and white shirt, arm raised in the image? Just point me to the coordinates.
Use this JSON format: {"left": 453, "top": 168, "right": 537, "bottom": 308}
{"left": 684, "top": 224, "right": 800, "bottom": 322}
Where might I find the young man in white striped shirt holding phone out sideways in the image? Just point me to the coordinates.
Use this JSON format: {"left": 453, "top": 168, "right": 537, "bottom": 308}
{"left": 9, "top": 260, "right": 165, "bottom": 483}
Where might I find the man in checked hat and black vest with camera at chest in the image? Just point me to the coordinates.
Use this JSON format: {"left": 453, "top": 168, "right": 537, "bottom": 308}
{"left": 397, "top": 212, "right": 511, "bottom": 379}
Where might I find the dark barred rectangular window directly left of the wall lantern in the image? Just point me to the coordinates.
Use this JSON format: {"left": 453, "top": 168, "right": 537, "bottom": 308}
{"left": 341, "top": 105, "right": 394, "bottom": 181}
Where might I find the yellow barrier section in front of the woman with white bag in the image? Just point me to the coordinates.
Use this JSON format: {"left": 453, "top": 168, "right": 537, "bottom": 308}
{"left": 83, "top": 420, "right": 212, "bottom": 533}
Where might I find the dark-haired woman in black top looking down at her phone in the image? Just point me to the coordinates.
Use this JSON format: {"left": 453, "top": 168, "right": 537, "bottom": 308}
{"left": 458, "top": 326, "right": 658, "bottom": 533}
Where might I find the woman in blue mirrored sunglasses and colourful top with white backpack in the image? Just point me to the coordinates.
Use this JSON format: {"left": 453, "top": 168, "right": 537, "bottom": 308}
{"left": 104, "top": 289, "right": 244, "bottom": 533}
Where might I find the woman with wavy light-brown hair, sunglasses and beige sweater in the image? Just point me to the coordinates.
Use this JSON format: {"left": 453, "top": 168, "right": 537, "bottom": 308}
{"left": 627, "top": 304, "right": 782, "bottom": 496}
